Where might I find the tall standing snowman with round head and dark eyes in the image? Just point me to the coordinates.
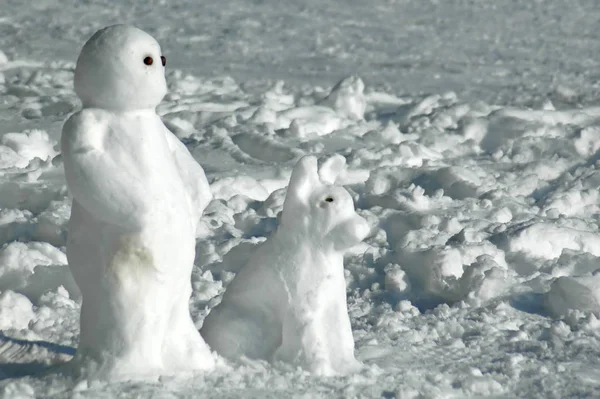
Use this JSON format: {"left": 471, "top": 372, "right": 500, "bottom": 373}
{"left": 61, "top": 25, "right": 214, "bottom": 378}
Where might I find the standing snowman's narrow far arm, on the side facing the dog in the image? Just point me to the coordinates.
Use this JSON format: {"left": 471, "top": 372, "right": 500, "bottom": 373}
{"left": 165, "top": 127, "right": 212, "bottom": 215}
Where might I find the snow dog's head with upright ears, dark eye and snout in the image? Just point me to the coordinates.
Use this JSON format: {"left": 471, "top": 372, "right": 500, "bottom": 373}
{"left": 280, "top": 154, "right": 369, "bottom": 251}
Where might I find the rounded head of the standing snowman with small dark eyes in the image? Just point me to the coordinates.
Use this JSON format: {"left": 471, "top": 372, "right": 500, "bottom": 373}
{"left": 75, "top": 25, "right": 167, "bottom": 111}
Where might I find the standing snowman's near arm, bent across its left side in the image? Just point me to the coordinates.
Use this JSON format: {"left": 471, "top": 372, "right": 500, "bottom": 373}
{"left": 61, "top": 112, "right": 148, "bottom": 228}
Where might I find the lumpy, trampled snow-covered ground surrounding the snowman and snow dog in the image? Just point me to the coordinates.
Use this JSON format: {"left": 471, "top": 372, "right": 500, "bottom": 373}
{"left": 0, "top": 0, "right": 600, "bottom": 398}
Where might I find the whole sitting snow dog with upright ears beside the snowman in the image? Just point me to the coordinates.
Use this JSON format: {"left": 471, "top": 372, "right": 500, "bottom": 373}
{"left": 200, "top": 156, "right": 369, "bottom": 375}
